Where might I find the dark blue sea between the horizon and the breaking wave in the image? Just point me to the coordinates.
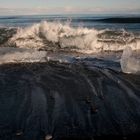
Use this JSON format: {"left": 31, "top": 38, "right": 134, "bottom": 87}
{"left": 0, "top": 15, "right": 140, "bottom": 31}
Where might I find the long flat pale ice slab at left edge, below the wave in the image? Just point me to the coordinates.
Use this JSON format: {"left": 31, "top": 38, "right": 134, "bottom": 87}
{"left": 0, "top": 48, "right": 47, "bottom": 64}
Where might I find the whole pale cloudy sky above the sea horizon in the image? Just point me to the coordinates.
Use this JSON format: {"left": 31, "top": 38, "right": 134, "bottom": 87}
{"left": 0, "top": 0, "right": 140, "bottom": 15}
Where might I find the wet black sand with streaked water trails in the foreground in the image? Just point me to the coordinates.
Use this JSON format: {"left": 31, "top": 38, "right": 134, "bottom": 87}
{"left": 0, "top": 62, "right": 140, "bottom": 140}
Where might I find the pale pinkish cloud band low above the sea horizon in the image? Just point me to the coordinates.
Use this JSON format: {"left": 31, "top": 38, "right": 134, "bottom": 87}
{"left": 0, "top": 6, "right": 140, "bottom": 15}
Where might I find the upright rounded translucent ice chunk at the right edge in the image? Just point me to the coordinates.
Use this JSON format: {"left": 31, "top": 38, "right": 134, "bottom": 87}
{"left": 120, "top": 47, "right": 140, "bottom": 74}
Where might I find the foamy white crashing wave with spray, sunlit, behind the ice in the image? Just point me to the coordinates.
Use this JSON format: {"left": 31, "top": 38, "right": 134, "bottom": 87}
{"left": 10, "top": 21, "right": 140, "bottom": 53}
